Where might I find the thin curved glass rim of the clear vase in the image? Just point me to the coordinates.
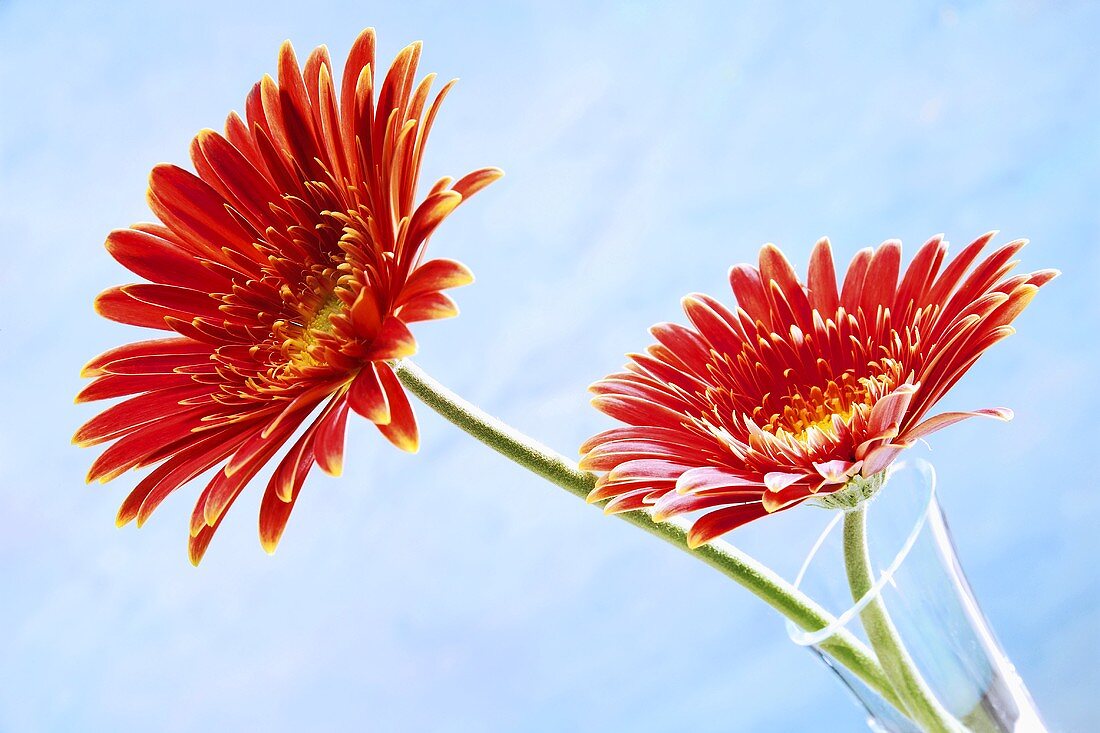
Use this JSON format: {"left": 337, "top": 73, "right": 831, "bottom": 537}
{"left": 787, "top": 458, "right": 937, "bottom": 646}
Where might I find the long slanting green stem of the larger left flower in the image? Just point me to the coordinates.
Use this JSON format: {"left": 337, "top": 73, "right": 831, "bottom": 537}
{"left": 395, "top": 361, "right": 904, "bottom": 712}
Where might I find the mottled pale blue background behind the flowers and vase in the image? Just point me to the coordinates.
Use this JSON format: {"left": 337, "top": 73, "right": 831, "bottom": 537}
{"left": 0, "top": 0, "right": 1100, "bottom": 733}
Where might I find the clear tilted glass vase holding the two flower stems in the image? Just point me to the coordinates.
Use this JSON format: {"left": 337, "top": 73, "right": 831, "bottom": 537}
{"left": 788, "top": 459, "right": 1046, "bottom": 733}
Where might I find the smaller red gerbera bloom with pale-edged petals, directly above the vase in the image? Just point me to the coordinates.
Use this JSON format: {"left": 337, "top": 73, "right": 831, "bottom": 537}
{"left": 581, "top": 234, "right": 1057, "bottom": 546}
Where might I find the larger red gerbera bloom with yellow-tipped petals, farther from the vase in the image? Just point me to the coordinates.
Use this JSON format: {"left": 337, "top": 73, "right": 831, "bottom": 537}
{"left": 74, "top": 30, "right": 502, "bottom": 564}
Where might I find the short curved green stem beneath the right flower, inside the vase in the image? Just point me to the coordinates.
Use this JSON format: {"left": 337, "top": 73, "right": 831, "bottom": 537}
{"left": 844, "top": 501, "right": 963, "bottom": 733}
